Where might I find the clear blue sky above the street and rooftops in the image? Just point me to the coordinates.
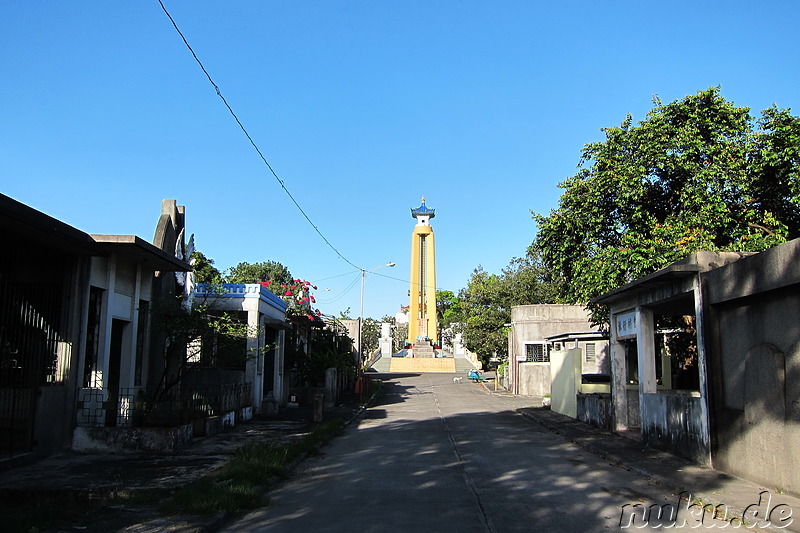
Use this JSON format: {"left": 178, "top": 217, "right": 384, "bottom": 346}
{"left": 0, "top": 0, "right": 800, "bottom": 318}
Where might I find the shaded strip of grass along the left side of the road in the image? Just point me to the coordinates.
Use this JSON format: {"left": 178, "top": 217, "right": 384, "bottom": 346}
{"left": 0, "top": 418, "right": 344, "bottom": 533}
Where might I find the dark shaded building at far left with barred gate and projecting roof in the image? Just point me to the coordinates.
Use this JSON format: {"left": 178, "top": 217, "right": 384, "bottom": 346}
{"left": 0, "top": 195, "right": 191, "bottom": 461}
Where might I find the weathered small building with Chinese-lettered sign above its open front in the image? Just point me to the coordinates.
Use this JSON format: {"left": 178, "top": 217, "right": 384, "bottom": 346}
{"left": 595, "top": 252, "right": 742, "bottom": 465}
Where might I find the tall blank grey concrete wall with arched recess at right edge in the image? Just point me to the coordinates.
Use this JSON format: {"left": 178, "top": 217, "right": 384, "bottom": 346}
{"left": 704, "top": 240, "right": 800, "bottom": 493}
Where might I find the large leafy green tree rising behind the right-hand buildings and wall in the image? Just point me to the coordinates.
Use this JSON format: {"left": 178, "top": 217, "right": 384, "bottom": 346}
{"left": 533, "top": 88, "right": 800, "bottom": 322}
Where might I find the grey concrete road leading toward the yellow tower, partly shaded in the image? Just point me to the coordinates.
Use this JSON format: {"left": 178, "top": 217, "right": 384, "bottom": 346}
{"left": 226, "top": 374, "right": 712, "bottom": 533}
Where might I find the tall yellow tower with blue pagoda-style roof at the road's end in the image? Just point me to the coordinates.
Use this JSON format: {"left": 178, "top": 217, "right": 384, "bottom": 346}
{"left": 408, "top": 196, "right": 438, "bottom": 350}
